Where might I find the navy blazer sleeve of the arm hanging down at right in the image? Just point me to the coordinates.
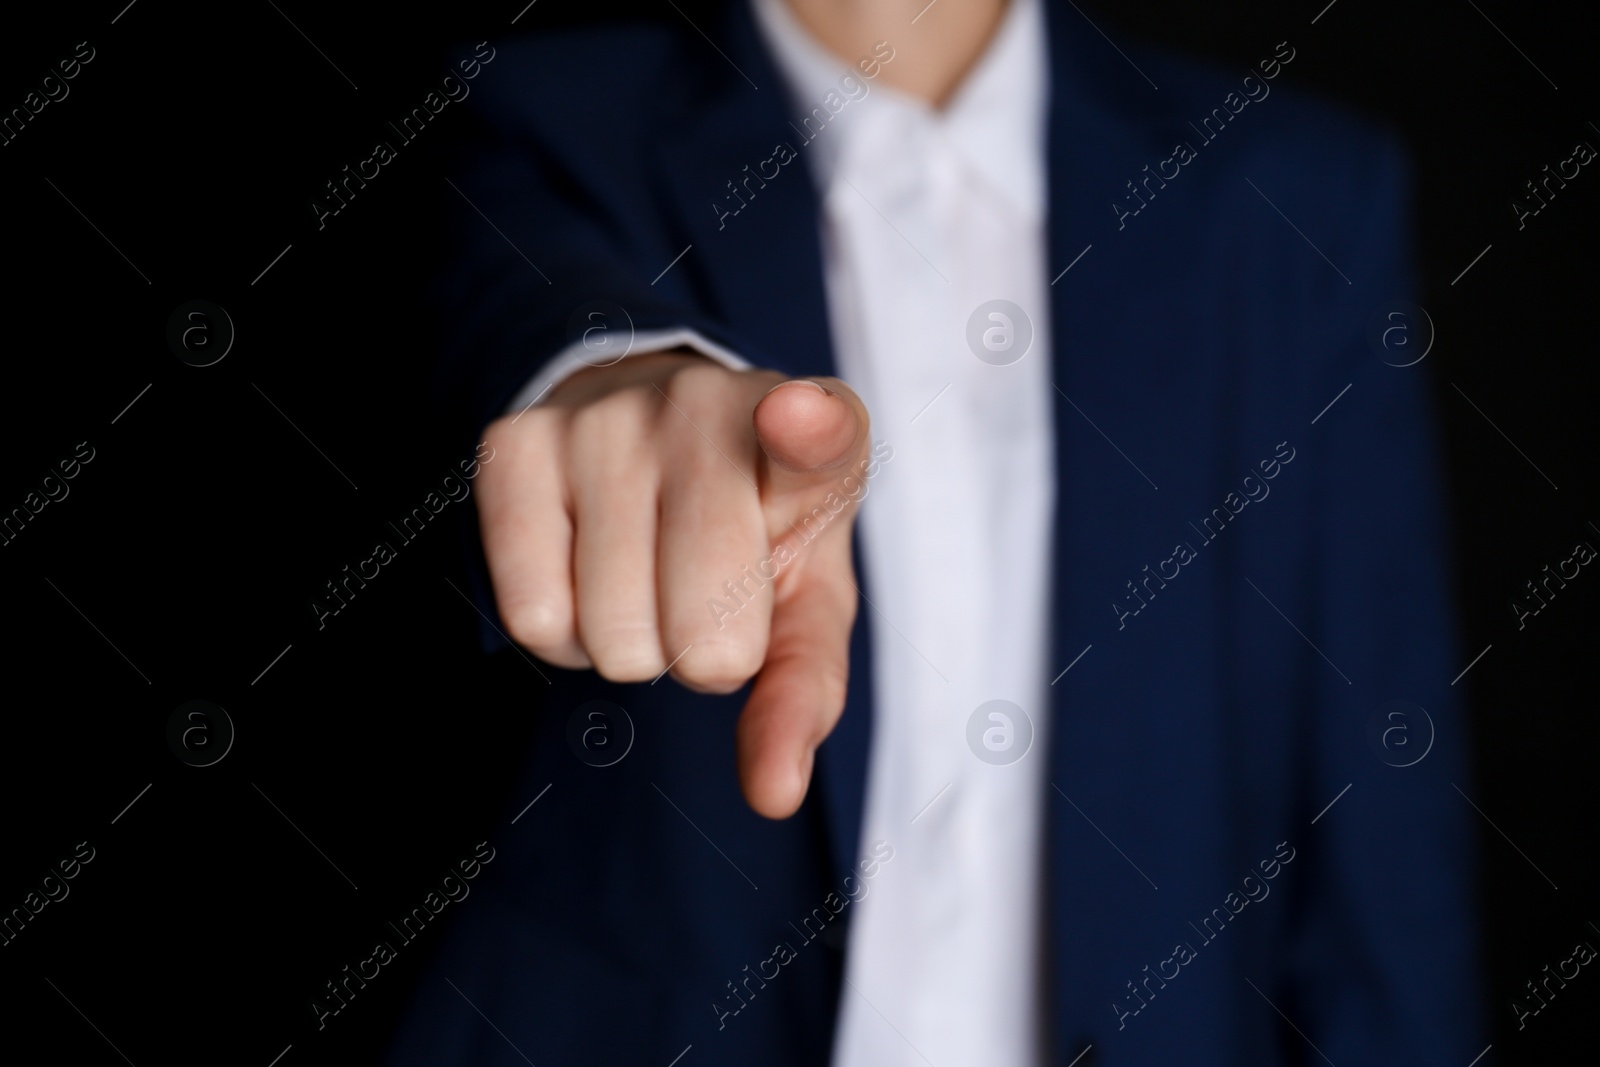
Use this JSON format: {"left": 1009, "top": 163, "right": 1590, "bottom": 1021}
{"left": 1280, "top": 129, "right": 1483, "bottom": 1067}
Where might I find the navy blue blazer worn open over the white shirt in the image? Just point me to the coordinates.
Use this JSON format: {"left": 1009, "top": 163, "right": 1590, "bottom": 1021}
{"left": 390, "top": 0, "right": 1483, "bottom": 1067}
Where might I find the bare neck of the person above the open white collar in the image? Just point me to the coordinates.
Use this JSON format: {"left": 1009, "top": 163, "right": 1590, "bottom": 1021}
{"left": 784, "top": 0, "right": 1006, "bottom": 107}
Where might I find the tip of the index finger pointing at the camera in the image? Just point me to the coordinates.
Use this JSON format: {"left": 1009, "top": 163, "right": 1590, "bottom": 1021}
{"left": 750, "top": 378, "right": 870, "bottom": 502}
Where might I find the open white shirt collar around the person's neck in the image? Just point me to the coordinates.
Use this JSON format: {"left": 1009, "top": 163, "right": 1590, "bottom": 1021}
{"left": 750, "top": 0, "right": 1050, "bottom": 218}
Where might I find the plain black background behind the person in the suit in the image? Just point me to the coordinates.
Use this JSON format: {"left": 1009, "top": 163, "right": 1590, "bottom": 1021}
{"left": 0, "top": 0, "right": 1600, "bottom": 1067}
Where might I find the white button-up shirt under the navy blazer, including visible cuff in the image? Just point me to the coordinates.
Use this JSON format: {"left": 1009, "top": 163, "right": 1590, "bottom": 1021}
{"left": 512, "top": 0, "right": 1054, "bottom": 1067}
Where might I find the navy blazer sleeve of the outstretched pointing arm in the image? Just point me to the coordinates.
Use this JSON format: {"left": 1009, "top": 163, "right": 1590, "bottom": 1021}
{"left": 432, "top": 35, "right": 761, "bottom": 440}
